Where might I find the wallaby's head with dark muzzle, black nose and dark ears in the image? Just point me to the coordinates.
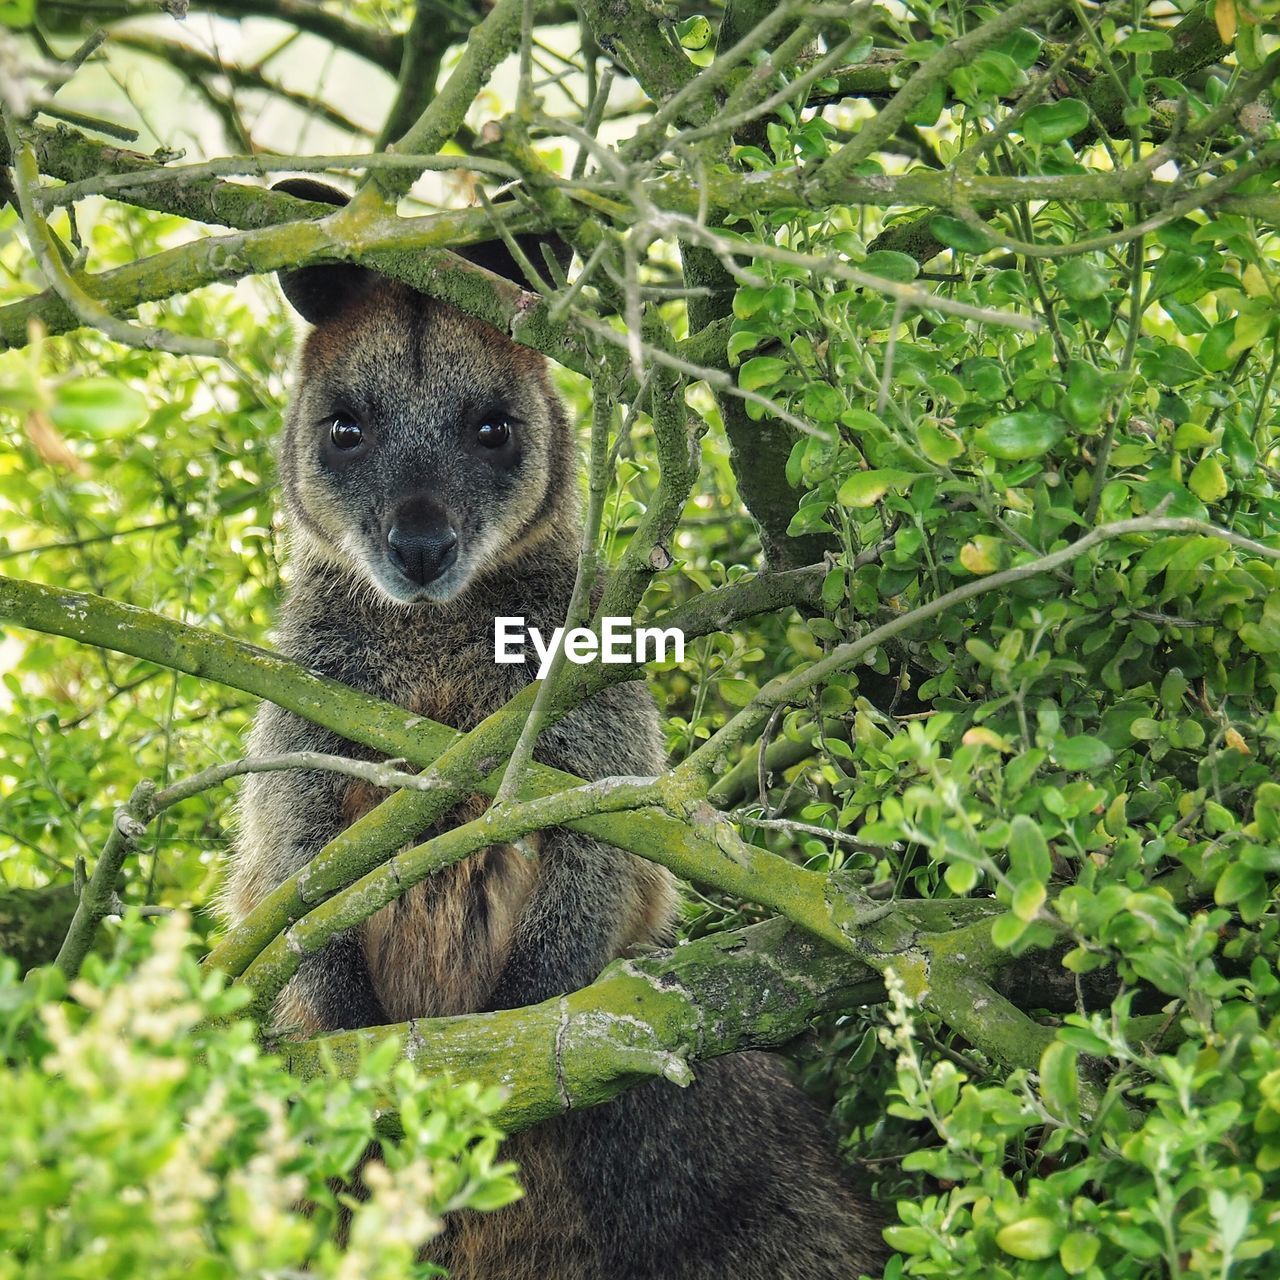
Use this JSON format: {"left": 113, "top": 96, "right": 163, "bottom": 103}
{"left": 279, "top": 179, "right": 576, "bottom": 604}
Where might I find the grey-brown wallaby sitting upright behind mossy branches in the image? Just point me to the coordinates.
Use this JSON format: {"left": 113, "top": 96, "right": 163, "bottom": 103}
{"left": 224, "top": 179, "right": 883, "bottom": 1280}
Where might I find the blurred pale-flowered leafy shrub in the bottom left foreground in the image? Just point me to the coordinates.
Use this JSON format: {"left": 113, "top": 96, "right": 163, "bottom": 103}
{"left": 0, "top": 916, "right": 520, "bottom": 1280}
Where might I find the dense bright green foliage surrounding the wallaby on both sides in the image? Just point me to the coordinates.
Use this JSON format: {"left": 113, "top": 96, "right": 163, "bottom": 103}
{"left": 0, "top": 0, "right": 1280, "bottom": 1280}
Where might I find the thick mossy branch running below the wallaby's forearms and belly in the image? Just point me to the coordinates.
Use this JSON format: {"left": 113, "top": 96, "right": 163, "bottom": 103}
{"left": 282, "top": 919, "right": 883, "bottom": 1132}
